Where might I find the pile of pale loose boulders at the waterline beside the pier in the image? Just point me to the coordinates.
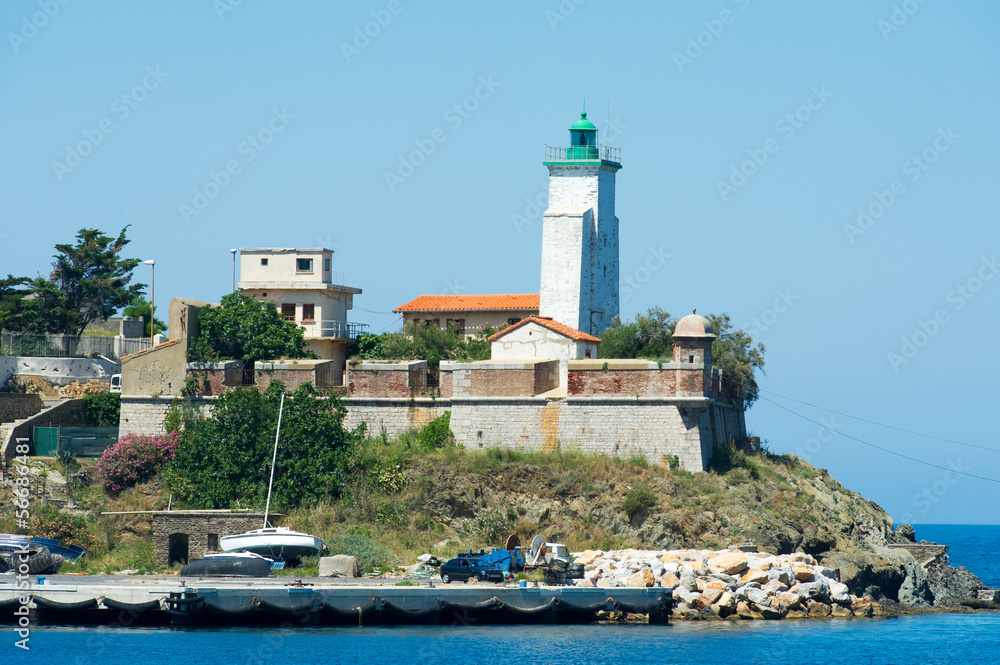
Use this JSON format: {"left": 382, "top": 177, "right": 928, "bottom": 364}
{"left": 574, "top": 550, "right": 884, "bottom": 620}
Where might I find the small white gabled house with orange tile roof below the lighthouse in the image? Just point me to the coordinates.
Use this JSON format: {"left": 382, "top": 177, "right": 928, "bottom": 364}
{"left": 490, "top": 316, "right": 601, "bottom": 389}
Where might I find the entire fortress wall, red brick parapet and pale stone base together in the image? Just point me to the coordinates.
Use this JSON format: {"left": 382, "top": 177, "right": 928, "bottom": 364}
{"left": 120, "top": 359, "right": 747, "bottom": 471}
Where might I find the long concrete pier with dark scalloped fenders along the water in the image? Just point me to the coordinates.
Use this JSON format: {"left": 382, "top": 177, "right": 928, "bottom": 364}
{"left": 0, "top": 575, "right": 672, "bottom": 626}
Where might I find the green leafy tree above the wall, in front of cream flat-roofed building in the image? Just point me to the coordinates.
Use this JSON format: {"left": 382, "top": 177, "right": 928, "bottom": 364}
{"left": 188, "top": 291, "right": 316, "bottom": 362}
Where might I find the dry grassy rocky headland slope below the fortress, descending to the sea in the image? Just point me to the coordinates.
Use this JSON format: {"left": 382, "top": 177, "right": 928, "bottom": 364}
{"left": 407, "top": 454, "right": 985, "bottom": 616}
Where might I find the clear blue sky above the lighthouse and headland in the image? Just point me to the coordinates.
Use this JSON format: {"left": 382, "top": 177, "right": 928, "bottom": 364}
{"left": 0, "top": 0, "right": 1000, "bottom": 523}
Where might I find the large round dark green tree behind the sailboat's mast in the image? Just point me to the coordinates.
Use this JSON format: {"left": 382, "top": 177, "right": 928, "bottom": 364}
{"left": 167, "top": 381, "right": 364, "bottom": 509}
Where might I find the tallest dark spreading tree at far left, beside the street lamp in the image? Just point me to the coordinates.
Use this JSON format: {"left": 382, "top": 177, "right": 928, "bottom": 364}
{"left": 52, "top": 226, "right": 146, "bottom": 335}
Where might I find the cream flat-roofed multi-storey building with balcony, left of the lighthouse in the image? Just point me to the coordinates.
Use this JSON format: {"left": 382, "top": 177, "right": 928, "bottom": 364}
{"left": 239, "top": 247, "right": 368, "bottom": 372}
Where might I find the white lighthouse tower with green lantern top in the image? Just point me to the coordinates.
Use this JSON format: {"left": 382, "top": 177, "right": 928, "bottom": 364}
{"left": 539, "top": 111, "right": 622, "bottom": 335}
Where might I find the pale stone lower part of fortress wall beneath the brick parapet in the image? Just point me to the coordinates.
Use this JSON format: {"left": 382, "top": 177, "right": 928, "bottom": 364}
{"left": 119, "top": 395, "right": 746, "bottom": 471}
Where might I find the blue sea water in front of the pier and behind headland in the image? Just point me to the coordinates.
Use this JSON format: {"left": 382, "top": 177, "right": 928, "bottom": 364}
{"left": 9, "top": 525, "right": 1000, "bottom": 665}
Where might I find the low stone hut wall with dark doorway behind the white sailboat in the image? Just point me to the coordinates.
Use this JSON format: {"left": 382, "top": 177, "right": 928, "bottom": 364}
{"left": 153, "top": 510, "right": 281, "bottom": 566}
